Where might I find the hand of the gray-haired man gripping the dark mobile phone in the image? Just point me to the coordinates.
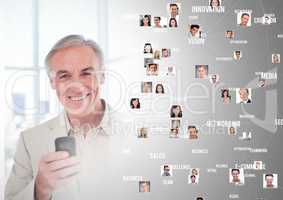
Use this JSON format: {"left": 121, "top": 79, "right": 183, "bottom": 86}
{"left": 35, "top": 151, "right": 79, "bottom": 200}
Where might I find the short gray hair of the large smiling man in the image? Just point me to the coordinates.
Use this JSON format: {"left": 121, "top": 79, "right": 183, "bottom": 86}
{"left": 45, "top": 35, "right": 104, "bottom": 75}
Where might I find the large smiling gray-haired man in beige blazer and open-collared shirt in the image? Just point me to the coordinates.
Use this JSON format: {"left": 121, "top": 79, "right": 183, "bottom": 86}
{"left": 5, "top": 35, "right": 130, "bottom": 200}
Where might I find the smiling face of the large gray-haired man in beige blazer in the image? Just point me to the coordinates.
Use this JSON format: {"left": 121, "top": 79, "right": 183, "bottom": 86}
{"left": 50, "top": 46, "right": 100, "bottom": 116}
